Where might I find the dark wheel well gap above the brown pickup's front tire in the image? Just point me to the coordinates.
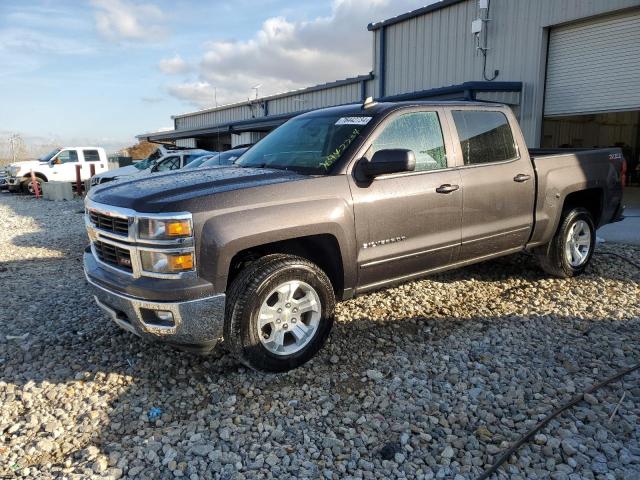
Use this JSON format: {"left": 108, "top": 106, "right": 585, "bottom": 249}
{"left": 227, "top": 234, "right": 344, "bottom": 298}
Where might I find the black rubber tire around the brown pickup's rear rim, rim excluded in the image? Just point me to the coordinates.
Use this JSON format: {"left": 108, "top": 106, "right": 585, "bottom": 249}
{"left": 536, "top": 207, "right": 596, "bottom": 278}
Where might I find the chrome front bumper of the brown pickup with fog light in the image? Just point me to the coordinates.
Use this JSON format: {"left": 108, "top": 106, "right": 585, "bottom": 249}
{"left": 85, "top": 263, "right": 226, "bottom": 353}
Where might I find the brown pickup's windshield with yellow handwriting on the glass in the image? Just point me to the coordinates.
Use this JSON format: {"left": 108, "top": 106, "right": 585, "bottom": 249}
{"left": 236, "top": 115, "right": 372, "bottom": 175}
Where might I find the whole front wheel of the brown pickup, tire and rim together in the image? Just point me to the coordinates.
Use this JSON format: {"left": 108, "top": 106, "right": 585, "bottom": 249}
{"left": 224, "top": 254, "right": 335, "bottom": 372}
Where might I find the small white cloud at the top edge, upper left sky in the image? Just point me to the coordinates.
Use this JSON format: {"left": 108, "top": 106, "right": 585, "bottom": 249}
{"left": 91, "top": 0, "right": 166, "bottom": 41}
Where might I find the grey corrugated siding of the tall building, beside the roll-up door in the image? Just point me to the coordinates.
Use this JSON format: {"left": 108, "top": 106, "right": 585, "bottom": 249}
{"left": 374, "top": 0, "right": 640, "bottom": 146}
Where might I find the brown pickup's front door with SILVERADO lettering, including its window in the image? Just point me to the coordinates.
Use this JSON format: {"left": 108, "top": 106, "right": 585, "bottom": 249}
{"left": 350, "top": 109, "right": 462, "bottom": 291}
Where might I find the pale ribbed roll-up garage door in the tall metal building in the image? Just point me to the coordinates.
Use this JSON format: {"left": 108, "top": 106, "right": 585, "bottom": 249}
{"left": 544, "top": 11, "right": 640, "bottom": 115}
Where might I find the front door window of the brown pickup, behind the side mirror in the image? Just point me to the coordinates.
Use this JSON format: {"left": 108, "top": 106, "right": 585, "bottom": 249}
{"left": 371, "top": 112, "right": 447, "bottom": 172}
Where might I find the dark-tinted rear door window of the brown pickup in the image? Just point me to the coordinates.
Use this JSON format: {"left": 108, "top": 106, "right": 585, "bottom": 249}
{"left": 452, "top": 110, "right": 518, "bottom": 165}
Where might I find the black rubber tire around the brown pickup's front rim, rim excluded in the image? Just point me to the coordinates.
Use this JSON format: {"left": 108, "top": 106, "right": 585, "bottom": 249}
{"left": 223, "top": 254, "right": 335, "bottom": 372}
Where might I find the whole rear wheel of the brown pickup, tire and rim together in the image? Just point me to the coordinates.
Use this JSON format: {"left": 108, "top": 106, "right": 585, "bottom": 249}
{"left": 538, "top": 208, "right": 596, "bottom": 278}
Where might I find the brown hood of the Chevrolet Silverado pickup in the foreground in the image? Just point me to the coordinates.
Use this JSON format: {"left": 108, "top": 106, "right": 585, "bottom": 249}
{"left": 89, "top": 166, "right": 308, "bottom": 213}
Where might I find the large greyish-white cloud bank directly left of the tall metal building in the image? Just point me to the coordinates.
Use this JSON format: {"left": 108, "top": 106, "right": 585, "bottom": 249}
{"left": 169, "top": 0, "right": 428, "bottom": 107}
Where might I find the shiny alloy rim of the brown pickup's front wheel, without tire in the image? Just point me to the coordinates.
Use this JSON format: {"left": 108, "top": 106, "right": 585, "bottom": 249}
{"left": 257, "top": 280, "right": 322, "bottom": 355}
